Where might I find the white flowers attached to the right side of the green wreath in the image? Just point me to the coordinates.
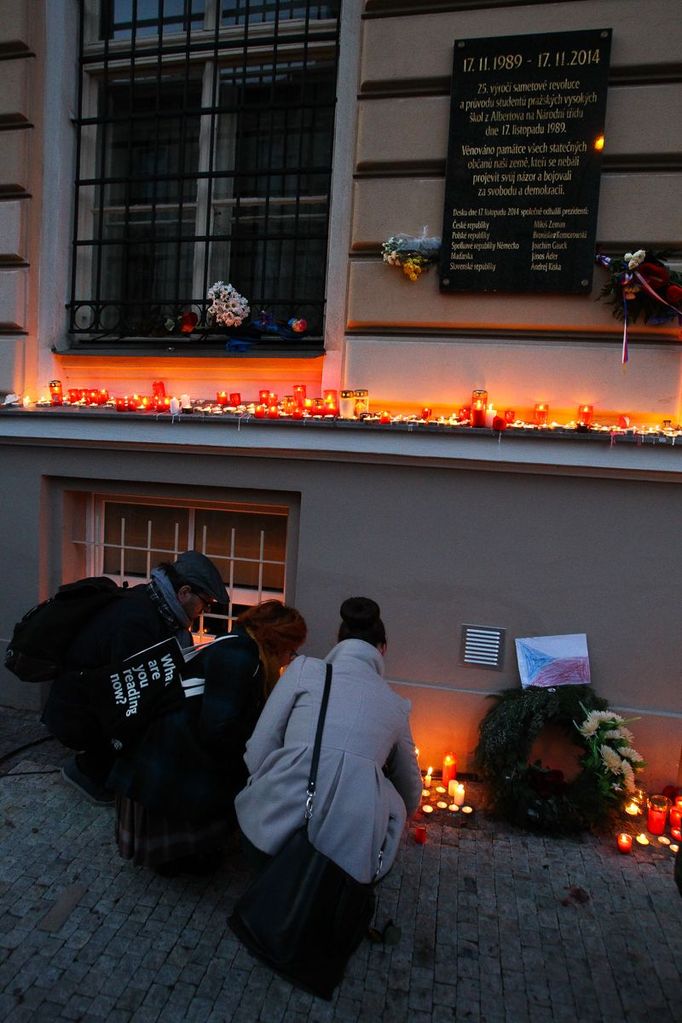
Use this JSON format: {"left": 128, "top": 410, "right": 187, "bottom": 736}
{"left": 576, "top": 704, "right": 644, "bottom": 798}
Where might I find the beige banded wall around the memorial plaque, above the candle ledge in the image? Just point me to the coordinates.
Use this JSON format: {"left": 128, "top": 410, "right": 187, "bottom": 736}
{"left": 346, "top": 0, "right": 682, "bottom": 421}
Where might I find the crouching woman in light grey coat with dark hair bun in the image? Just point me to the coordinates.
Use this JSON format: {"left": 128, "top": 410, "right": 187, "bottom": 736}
{"left": 235, "top": 597, "right": 421, "bottom": 883}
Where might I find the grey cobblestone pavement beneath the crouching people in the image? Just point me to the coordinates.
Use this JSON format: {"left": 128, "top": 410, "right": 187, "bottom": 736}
{"left": 0, "top": 709, "right": 682, "bottom": 1023}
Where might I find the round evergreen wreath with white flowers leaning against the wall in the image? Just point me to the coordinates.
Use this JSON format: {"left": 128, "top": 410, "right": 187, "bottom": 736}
{"left": 474, "top": 685, "right": 643, "bottom": 834}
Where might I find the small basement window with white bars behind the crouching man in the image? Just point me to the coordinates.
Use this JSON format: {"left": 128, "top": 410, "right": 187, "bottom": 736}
{"left": 74, "top": 496, "right": 288, "bottom": 641}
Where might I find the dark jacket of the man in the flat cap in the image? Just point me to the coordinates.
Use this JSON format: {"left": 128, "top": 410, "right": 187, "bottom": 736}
{"left": 42, "top": 584, "right": 191, "bottom": 752}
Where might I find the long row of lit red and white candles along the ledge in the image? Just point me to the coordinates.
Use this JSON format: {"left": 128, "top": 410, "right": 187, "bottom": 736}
{"left": 9, "top": 380, "right": 682, "bottom": 437}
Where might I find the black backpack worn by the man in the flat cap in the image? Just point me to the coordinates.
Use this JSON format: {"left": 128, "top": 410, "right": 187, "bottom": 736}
{"left": 5, "top": 576, "right": 126, "bottom": 682}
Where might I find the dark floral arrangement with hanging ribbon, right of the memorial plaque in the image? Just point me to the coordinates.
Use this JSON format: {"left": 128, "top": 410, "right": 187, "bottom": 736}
{"left": 596, "top": 249, "right": 682, "bottom": 323}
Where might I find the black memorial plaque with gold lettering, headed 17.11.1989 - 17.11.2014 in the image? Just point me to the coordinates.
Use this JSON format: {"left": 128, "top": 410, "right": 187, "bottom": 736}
{"left": 440, "top": 29, "right": 611, "bottom": 293}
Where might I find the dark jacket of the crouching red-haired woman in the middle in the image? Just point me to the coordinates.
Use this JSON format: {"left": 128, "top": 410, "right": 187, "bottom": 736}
{"left": 107, "top": 629, "right": 263, "bottom": 821}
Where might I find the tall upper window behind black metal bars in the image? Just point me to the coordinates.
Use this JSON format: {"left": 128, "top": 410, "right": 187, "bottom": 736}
{"left": 69, "top": 0, "right": 339, "bottom": 350}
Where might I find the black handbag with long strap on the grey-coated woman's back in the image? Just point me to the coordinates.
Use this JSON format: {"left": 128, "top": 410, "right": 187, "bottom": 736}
{"left": 229, "top": 665, "right": 374, "bottom": 999}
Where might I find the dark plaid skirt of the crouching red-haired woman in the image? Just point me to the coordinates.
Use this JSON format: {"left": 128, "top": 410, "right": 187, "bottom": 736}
{"left": 116, "top": 796, "right": 228, "bottom": 866}
